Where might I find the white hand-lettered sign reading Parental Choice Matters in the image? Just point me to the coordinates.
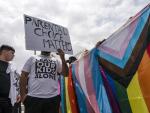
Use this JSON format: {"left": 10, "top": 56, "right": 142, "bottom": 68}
{"left": 24, "top": 15, "right": 73, "bottom": 54}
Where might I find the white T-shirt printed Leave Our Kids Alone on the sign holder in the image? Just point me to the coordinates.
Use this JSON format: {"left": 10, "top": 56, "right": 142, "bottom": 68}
{"left": 22, "top": 55, "right": 62, "bottom": 98}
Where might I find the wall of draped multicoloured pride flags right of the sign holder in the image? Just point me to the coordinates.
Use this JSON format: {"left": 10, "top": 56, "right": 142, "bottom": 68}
{"left": 61, "top": 4, "right": 150, "bottom": 113}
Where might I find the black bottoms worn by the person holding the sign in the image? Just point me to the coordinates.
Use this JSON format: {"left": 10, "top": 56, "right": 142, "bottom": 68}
{"left": 23, "top": 95, "right": 60, "bottom": 113}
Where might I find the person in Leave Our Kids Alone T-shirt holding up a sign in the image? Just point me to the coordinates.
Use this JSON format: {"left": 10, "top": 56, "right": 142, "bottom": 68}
{"left": 20, "top": 49, "right": 68, "bottom": 113}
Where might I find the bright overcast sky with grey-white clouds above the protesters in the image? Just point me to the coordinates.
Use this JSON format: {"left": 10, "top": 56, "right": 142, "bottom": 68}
{"left": 0, "top": 0, "right": 150, "bottom": 71}
